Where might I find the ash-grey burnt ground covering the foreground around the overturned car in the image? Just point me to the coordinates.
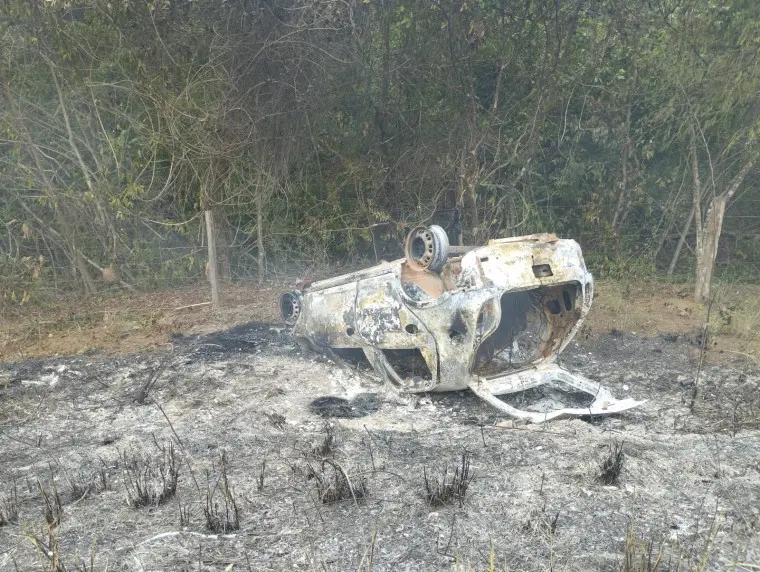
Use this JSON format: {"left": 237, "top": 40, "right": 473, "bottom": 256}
{"left": 0, "top": 324, "right": 760, "bottom": 571}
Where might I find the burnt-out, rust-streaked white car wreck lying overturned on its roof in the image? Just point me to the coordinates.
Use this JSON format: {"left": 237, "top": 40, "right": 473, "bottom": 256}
{"left": 280, "top": 226, "right": 643, "bottom": 423}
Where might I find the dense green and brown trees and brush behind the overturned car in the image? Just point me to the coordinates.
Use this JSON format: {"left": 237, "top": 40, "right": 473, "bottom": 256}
{"left": 0, "top": 0, "right": 760, "bottom": 309}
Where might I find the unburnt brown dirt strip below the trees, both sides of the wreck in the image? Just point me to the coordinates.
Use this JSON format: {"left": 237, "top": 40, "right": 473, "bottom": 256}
{"left": 0, "top": 281, "right": 760, "bottom": 361}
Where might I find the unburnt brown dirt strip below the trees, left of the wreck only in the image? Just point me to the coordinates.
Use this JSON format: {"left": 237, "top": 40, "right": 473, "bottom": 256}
{"left": 0, "top": 282, "right": 289, "bottom": 361}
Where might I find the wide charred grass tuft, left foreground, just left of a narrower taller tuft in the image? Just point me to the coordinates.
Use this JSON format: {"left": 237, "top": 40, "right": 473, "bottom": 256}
{"left": 121, "top": 441, "right": 182, "bottom": 508}
